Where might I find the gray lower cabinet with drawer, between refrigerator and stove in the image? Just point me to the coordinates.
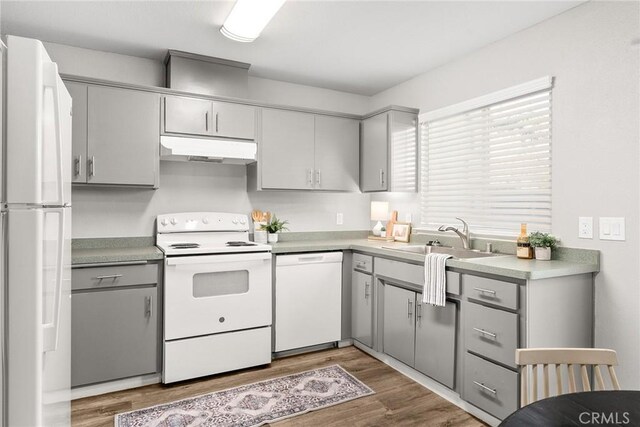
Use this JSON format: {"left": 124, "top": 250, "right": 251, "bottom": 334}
{"left": 71, "top": 264, "right": 160, "bottom": 387}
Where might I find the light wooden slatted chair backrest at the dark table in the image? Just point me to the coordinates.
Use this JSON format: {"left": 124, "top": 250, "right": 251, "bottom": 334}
{"left": 516, "top": 348, "right": 620, "bottom": 406}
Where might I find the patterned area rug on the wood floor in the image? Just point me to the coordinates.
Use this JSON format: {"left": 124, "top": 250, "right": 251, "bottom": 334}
{"left": 115, "top": 365, "right": 374, "bottom": 427}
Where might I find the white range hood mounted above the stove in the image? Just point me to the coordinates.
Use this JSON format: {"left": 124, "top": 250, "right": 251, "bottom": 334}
{"left": 160, "top": 135, "right": 258, "bottom": 165}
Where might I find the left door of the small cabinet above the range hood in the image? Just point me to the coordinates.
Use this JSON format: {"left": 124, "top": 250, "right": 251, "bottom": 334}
{"left": 164, "top": 96, "right": 214, "bottom": 136}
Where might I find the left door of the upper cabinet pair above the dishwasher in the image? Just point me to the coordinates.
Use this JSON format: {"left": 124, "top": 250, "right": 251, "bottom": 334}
{"left": 259, "top": 108, "right": 314, "bottom": 190}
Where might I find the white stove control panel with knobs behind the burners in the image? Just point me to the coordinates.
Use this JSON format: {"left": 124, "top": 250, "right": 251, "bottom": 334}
{"left": 157, "top": 212, "right": 249, "bottom": 233}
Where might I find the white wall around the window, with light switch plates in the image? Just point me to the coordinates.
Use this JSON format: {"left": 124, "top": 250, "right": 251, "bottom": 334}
{"left": 370, "top": 2, "right": 640, "bottom": 388}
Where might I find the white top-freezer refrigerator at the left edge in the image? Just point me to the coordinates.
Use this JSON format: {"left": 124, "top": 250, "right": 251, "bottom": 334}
{"left": 0, "top": 36, "right": 71, "bottom": 427}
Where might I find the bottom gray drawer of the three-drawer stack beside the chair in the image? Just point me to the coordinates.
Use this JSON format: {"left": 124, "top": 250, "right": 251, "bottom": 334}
{"left": 463, "top": 353, "right": 518, "bottom": 419}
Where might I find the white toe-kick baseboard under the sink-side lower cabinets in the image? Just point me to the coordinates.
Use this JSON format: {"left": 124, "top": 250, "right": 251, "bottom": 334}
{"left": 353, "top": 341, "right": 501, "bottom": 426}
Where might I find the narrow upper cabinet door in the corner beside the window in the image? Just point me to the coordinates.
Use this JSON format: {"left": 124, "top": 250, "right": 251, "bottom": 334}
{"left": 360, "top": 114, "right": 389, "bottom": 192}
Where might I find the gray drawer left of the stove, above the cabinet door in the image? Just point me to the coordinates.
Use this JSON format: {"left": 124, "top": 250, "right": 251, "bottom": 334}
{"left": 71, "top": 264, "right": 158, "bottom": 291}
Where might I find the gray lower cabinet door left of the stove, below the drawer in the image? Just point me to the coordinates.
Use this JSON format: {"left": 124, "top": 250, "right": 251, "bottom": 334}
{"left": 71, "top": 287, "right": 158, "bottom": 386}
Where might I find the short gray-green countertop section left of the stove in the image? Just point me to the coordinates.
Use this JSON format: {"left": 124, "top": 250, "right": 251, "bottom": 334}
{"left": 71, "top": 237, "right": 164, "bottom": 265}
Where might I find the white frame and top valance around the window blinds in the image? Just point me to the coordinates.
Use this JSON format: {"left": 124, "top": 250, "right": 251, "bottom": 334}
{"left": 415, "top": 76, "right": 553, "bottom": 238}
